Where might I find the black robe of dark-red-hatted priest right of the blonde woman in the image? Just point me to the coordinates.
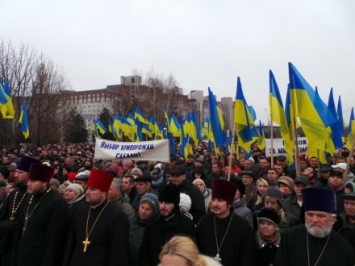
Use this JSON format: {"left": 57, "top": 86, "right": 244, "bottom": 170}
{"left": 197, "top": 210, "right": 256, "bottom": 266}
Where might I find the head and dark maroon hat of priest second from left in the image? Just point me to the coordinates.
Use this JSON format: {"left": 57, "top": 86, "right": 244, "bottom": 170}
{"left": 27, "top": 163, "right": 54, "bottom": 195}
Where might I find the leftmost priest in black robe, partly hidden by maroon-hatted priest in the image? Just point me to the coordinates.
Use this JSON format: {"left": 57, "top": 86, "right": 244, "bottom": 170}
{"left": 0, "top": 156, "right": 41, "bottom": 265}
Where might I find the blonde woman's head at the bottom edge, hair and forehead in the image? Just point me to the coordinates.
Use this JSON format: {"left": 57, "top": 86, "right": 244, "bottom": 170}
{"left": 159, "top": 236, "right": 205, "bottom": 266}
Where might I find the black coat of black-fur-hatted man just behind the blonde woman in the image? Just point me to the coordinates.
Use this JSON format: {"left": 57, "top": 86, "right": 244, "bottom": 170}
{"left": 140, "top": 212, "right": 196, "bottom": 266}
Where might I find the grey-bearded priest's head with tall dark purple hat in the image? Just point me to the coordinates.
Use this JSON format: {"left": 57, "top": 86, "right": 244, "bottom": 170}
{"left": 302, "top": 188, "right": 336, "bottom": 238}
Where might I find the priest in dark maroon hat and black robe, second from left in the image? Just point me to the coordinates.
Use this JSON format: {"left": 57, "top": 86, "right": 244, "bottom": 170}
{"left": 16, "top": 163, "right": 68, "bottom": 266}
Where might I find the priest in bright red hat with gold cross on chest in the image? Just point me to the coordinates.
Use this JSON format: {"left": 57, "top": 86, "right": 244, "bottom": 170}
{"left": 63, "top": 169, "right": 129, "bottom": 266}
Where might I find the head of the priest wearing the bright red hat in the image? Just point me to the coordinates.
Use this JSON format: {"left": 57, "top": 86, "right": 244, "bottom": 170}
{"left": 85, "top": 169, "right": 113, "bottom": 205}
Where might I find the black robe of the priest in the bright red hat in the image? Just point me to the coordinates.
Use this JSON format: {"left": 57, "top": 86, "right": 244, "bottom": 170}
{"left": 63, "top": 200, "right": 129, "bottom": 266}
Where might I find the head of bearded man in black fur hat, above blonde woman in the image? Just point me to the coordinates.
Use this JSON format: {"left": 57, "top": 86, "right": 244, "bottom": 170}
{"left": 159, "top": 183, "right": 180, "bottom": 218}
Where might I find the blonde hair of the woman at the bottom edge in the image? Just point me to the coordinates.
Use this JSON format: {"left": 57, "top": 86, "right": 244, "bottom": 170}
{"left": 159, "top": 236, "right": 207, "bottom": 266}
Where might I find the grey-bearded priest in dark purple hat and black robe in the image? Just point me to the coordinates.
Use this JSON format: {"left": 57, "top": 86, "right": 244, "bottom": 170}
{"left": 275, "top": 188, "right": 355, "bottom": 266}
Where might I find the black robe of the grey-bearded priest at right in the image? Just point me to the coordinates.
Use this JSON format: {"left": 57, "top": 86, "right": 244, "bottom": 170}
{"left": 275, "top": 225, "right": 355, "bottom": 266}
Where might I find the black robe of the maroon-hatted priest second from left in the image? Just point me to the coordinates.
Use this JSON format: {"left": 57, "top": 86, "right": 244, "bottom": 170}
{"left": 16, "top": 190, "right": 69, "bottom": 266}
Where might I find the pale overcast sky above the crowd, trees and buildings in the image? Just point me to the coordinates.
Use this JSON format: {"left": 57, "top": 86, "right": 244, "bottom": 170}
{"left": 0, "top": 0, "right": 355, "bottom": 123}
